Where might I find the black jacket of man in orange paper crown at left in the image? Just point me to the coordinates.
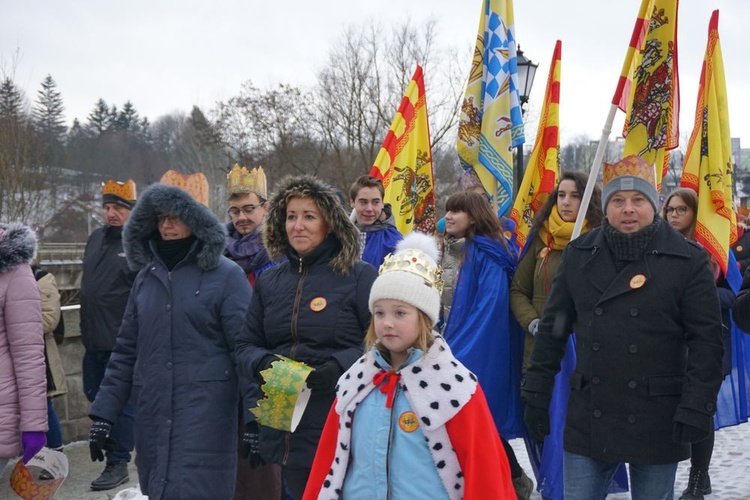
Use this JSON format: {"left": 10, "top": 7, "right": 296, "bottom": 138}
{"left": 81, "top": 226, "right": 138, "bottom": 351}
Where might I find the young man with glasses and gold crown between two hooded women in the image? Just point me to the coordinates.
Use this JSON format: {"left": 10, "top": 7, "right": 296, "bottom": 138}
{"left": 226, "top": 165, "right": 275, "bottom": 287}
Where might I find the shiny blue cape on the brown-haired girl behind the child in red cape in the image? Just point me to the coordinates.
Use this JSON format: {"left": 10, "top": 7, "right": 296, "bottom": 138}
{"left": 444, "top": 236, "right": 523, "bottom": 439}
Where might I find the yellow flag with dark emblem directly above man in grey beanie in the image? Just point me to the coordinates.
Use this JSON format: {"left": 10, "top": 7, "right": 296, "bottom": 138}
{"left": 623, "top": 0, "right": 680, "bottom": 191}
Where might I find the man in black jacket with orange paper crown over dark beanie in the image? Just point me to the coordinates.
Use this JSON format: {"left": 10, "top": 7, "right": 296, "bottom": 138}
{"left": 81, "top": 180, "right": 136, "bottom": 490}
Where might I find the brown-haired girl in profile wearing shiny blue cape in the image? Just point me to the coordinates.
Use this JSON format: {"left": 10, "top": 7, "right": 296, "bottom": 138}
{"left": 441, "top": 191, "right": 534, "bottom": 499}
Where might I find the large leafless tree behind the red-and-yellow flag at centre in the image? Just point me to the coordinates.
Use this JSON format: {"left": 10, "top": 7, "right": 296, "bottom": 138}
{"left": 314, "top": 21, "right": 465, "bottom": 185}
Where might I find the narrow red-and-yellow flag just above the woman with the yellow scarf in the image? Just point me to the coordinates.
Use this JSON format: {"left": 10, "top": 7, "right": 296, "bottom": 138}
{"left": 510, "top": 40, "right": 562, "bottom": 249}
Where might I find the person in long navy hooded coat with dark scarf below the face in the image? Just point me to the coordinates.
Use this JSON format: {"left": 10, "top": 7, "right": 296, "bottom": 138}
{"left": 89, "top": 184, "right": 252, "bottom": 499}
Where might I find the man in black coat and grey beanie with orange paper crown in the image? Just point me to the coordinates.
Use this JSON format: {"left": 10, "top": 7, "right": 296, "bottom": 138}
{"left": 521, "top": 156, "right": 723, "bottom": 499}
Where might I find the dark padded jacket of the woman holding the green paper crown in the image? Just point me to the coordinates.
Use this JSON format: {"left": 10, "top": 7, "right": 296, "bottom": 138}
{"left": 237, "top": 236, "right": 377, "bottom": 468}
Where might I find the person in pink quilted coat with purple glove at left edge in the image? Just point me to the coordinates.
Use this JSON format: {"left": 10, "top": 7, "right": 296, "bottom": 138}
{"left": 0, "top": 224, "right": 47, "bottom": 474}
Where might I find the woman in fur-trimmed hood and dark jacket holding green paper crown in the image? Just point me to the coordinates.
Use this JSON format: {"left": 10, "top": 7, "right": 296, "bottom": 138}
{"left": 237, "top": 176, "right": 377, "bottom": 498}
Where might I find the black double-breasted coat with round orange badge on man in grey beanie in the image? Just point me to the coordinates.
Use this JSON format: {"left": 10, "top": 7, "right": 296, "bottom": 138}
{"left": 522, "top": 222, "right": 723, "bottom": 464}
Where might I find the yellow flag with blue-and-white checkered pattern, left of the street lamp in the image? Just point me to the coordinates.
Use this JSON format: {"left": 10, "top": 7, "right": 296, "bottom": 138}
{"left": 457, "top": 0, "right": 524, "bottom": 213}
